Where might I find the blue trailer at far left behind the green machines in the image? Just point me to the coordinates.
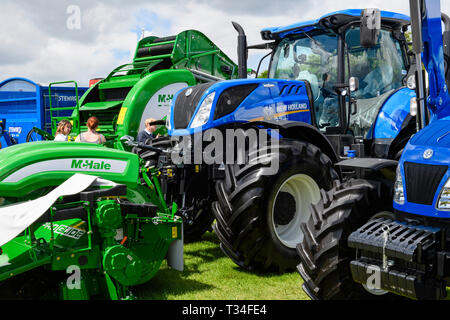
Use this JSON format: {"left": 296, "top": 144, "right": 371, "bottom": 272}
{"left": 0, "top": 78, "right": 88, "bottom": 146}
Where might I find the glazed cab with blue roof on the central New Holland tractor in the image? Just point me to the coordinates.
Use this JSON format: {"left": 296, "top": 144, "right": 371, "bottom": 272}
{"left": 262, "top": 10, "right": 410, "bottom": 138}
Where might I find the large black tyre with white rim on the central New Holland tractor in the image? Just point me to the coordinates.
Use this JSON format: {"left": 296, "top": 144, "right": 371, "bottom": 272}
{"left": 212, "top": 139, "right": 338, "bottom": 272}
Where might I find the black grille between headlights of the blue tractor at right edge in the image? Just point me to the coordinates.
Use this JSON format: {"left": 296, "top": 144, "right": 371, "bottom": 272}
{"left": 405, "top": 162, "right": 448, "bottom": 205}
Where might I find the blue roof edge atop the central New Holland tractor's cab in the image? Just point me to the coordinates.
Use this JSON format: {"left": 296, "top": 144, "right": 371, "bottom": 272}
{"left": 262, "top": 9, "right": 410, "bottom": 38}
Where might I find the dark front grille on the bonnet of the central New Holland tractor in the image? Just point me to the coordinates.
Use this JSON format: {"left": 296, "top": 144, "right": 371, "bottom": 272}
{"left": 173, "top": 82, "right": 215, "bottom": 129}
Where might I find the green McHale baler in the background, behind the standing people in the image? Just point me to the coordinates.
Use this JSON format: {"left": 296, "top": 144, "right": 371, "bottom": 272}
{"left": 44, "top": 30, "right": 238, "bottom": 148}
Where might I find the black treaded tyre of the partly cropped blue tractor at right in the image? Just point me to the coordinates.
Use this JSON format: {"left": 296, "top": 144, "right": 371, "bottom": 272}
{"left": 297, "top": 180, "right": 393, "bottom": 300}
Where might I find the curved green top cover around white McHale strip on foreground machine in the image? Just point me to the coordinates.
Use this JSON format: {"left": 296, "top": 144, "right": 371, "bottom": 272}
{"left": 0, "top": 141, "right": 139, "bottom": 198}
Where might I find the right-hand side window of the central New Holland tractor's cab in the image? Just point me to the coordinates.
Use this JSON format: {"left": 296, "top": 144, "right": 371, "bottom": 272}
{"left": 345, "top": 28, "right": 407, "bottom": 138}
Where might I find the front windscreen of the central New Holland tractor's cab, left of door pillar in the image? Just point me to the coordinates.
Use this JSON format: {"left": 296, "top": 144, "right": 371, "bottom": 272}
{"left": 269, "top": 31, "right": 340, "bottom": 131}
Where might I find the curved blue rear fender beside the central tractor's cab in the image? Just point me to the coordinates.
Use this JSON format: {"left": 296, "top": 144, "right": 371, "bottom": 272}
{"left": 372, "top": 88, "right": 416, "bottom": 139}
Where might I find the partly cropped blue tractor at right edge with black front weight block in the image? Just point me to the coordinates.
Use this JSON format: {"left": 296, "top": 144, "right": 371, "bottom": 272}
{"left": 297, "top": 0, "right": 450, "bottom": 300}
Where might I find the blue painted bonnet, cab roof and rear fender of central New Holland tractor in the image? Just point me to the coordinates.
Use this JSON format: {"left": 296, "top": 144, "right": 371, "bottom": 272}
{"left": 169, "top": 9, "right": 414, "bottom": 146}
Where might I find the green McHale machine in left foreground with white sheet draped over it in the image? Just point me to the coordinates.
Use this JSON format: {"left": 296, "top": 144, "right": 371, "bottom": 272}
{"left": 0, "top": 142, "right": 183, "bottom": 300}
